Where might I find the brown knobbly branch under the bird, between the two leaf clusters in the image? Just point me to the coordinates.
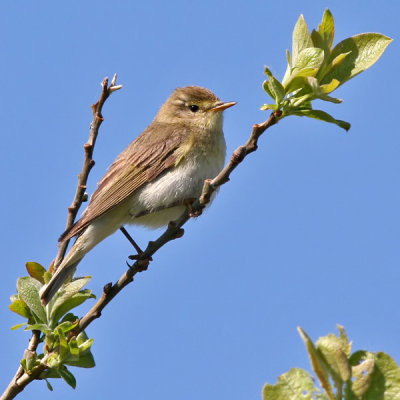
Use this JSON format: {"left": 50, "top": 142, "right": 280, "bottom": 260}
{"left": 76, "top": 111, "right": 281, "bottom": 334}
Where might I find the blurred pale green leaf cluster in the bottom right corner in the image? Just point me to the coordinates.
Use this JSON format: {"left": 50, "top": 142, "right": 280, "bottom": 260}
{"left": 262, "top": 326, "right": 400, "bottom": 400}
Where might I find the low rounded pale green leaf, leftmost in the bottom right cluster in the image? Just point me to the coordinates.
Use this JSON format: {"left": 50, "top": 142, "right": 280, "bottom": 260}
{"left": 262, "top": 368, "right": 321, "bottom": 400}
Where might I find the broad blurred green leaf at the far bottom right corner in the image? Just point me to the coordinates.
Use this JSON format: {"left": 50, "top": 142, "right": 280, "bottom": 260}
{"left": 345, "top": 351, "right": 400, "bottom": 400}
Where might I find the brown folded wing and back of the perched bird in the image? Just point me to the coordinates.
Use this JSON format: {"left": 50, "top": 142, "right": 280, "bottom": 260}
{"left": 59, "top": 122, "right": 190, "bottom": 241}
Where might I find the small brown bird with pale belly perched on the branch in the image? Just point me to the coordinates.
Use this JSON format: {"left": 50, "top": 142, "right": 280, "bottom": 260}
{"left": 41, "top": 86, "right": 236, "bottom": 305}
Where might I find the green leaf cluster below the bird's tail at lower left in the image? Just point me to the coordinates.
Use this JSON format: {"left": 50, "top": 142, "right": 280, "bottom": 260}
{"left": 9, "top": 262, "right": 95, "bottom": 389}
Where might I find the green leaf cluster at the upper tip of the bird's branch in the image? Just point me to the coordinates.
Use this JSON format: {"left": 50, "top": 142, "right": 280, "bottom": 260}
{"left": 261, "top": 9, "right": 392, "bottom": 130}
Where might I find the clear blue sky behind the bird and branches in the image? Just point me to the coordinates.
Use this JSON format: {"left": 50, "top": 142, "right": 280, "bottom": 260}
{"left": 0, "top": 0, "right": 400, "bottom": 400}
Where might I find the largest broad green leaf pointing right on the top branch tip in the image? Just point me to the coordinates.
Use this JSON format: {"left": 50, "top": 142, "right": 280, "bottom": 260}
{"left": 321, "top": 33, "right": 392, "bottom": 84}
